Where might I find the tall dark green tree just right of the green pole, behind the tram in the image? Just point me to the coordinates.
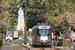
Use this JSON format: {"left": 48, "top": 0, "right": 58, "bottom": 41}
{"left": 22, "top": 0, "right": 45, "bottom": 29}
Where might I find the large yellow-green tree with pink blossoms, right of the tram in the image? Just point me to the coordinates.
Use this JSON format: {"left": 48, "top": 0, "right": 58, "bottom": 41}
{"left": 42, "top": 0, "right": 75, "bottom": 46}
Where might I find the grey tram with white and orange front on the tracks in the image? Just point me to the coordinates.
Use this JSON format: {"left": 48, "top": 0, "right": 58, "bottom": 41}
{"left": 32, "top": 25, "right": 52, "bottom": 46}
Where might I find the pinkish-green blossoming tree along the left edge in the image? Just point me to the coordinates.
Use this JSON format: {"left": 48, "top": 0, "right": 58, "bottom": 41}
{"left": 0, "top": 0, "right": 10, "bottom": 33}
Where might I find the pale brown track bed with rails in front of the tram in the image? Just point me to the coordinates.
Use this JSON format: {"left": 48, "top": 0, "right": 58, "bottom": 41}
{"left": 13, "top": 44, "right": 56, "bottom": 50}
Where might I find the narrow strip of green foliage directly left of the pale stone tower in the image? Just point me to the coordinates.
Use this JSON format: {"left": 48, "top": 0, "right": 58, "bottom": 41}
{"left": 9, "top": 0, "right": 18, "bottom": 30}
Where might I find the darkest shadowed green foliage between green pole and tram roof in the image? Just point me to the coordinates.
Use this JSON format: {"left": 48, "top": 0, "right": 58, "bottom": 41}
{"left": 27, "top": 12, "right": 38, "bottom": 29}
